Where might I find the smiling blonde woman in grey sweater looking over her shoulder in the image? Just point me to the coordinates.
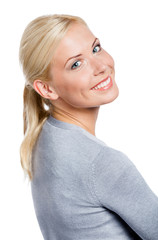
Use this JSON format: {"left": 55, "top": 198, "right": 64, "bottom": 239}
{"left": 20, "top": 14, "right": 158, "bottom": 240}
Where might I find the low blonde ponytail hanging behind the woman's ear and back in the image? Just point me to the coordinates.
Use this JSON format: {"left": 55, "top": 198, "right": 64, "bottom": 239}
{"left": 20, "top": 86, "right": 50, "bottom": 179}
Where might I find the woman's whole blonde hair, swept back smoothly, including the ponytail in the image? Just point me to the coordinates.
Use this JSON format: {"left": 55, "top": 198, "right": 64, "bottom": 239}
{"left": 19, "top": 14, "right": 87, "bottom": 180}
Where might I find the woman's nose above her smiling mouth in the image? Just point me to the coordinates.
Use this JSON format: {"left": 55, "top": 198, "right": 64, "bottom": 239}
{"left": 92, "top": 58, "right": 108, "bottom": 76}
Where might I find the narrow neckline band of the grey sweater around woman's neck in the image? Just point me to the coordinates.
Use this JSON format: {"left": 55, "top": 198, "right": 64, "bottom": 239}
{"left": 47, "top": 115, "right": 106, "bottom": 145}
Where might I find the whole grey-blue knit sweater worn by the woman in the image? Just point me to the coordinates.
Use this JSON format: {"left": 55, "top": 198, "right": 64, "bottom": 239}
{"left": 31, "top": 116, "right": 158, "bottom": 240}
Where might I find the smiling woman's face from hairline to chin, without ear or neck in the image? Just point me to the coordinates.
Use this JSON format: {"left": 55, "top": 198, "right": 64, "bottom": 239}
{"left": 50, "top": 23, "right": 118, "bottom": 108}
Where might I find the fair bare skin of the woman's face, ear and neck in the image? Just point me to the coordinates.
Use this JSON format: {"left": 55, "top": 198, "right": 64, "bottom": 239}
{"left": 33, "top": 23, "right": 119, "bottom": 136}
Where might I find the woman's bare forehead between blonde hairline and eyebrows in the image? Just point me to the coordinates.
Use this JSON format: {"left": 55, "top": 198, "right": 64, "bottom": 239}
{"left": 54, "top": 23, "right": 95, "bottom": 64}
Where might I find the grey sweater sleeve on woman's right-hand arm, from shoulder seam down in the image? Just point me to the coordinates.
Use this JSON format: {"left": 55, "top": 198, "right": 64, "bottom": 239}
{"left": 91, "top": 147, "right": 158, "bottom": 240}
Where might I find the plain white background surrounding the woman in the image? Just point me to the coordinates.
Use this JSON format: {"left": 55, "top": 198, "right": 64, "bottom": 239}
{"left": 0, "top": 0, "right": 158, "bottom": 240}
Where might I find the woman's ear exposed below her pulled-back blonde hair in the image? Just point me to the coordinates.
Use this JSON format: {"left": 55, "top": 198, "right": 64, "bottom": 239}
{"left": 33, "top": 80, "right": 59, "bottom": 100}
